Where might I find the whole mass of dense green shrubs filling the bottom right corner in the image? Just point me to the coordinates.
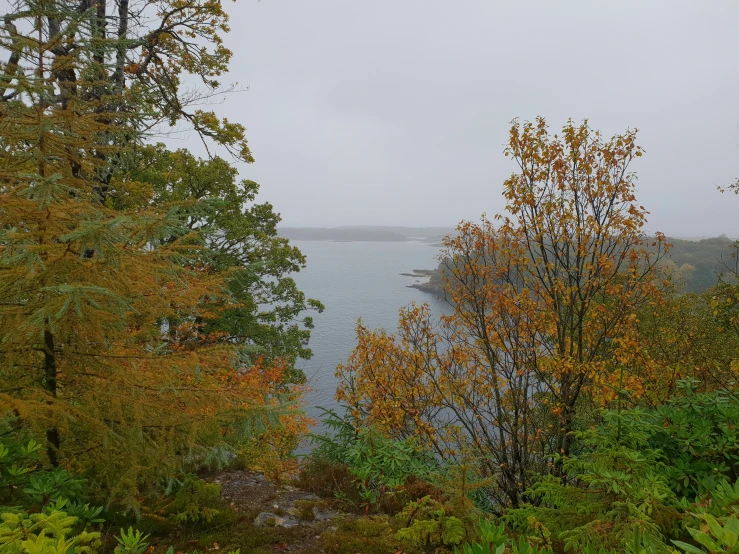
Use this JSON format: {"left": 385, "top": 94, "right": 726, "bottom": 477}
{"left": 505, "top": 380, "right": 739, "bottom": 551}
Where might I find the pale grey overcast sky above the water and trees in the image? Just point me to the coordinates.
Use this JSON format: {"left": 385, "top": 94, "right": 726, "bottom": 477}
{"left": 187, "top": 0, "right": 739, "bottom": 236}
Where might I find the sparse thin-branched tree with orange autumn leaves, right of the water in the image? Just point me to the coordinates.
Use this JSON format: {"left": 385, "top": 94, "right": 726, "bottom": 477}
{"left": 337, "top": 119, "right": 666, "bottom": 505}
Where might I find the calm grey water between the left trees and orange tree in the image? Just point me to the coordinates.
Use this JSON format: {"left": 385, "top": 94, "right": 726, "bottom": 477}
{"left": 292, "top": 241, "right": 447, "bottom": 424}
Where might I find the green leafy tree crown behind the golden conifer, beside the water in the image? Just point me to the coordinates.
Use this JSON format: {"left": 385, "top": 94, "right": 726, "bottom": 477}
{"left": 115, "top": 144, "right": 323, "bottom": 381}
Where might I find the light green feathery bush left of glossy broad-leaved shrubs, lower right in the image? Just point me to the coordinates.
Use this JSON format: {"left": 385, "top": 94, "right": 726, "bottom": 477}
{"left": 506, "top": 410, "right": 680, "bottom": 551}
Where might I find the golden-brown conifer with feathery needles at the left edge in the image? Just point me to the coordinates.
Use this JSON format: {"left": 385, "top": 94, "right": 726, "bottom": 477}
{"left": 0, "top": 0, "right": 303, "bottom": 506}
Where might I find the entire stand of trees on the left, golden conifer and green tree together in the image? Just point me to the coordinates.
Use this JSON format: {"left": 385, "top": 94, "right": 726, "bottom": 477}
{"left": 0, "top": 0, "right": 322, "bottom": 506}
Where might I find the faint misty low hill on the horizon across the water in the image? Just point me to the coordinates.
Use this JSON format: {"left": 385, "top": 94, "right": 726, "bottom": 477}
{"left": 277, "top": 225, "right": 454, "bottom": 243}
